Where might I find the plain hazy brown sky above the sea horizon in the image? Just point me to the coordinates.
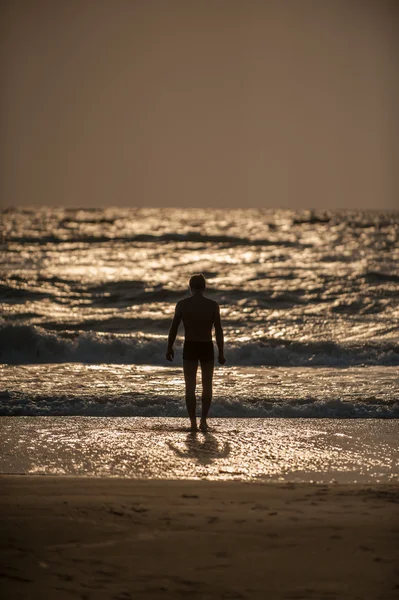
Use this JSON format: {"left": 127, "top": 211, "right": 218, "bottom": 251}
{"left": 0, "top": 0, "right": 399, "bottom": 209}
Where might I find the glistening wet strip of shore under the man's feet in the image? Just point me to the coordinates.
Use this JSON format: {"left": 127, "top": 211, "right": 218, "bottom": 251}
{"left": 0, "top": 417, "right": 399, "bottom": 482}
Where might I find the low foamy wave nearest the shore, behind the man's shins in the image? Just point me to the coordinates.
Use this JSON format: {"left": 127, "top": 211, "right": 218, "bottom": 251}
{"left": 0, "top": 391, "right": 399, "bottom": 419}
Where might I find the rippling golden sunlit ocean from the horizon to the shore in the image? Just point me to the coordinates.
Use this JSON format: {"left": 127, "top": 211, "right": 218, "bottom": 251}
{"left": 0, "top": 207, "right": 399, "bottom": 477}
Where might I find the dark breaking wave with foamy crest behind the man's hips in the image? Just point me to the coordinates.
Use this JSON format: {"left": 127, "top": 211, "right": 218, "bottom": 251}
{"left": 0, "top": 323, "right": 399, "bottom": 367}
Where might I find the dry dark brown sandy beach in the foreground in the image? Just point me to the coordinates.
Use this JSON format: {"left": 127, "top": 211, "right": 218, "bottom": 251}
{"left": 0, "top": 475, "right": 399, "bottom": 600}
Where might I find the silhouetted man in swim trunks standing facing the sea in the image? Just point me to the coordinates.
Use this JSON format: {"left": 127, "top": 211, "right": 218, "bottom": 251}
{"left": 166, "top": 274, "right": 226, "bottom": 432}
